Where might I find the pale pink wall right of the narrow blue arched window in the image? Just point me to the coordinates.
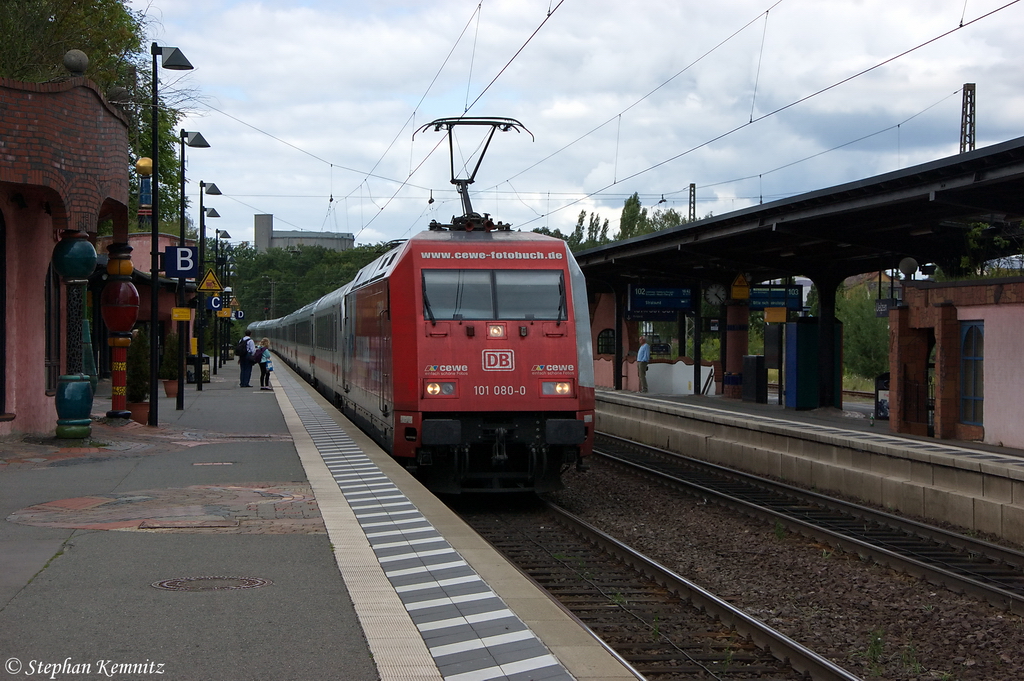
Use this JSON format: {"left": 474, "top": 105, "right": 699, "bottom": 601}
{"left": 957, "top": 305, "right": 1024, "bottom": 449}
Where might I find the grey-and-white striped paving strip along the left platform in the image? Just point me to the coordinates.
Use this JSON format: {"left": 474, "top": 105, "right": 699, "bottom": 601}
{"left": 276, "top": 372, "right": 572, "bottom": 681}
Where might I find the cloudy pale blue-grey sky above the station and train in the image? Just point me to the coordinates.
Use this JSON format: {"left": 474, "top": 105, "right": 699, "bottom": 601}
{"left": 132, "top": 0, "right": 1024, "bottom": 244}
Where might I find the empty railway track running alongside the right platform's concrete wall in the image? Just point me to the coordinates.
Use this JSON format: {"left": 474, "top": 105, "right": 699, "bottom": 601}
{"left": 595, "top": 434, "right": 1024, "bottom": 614}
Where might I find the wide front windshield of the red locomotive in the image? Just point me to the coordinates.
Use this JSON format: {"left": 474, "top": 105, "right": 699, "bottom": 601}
{"left": 423, "top": 269, "right": 567, "bottom": 321}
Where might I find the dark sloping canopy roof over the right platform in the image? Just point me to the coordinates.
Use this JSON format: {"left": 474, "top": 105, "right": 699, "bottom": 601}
{"left": 575, "top": 137, "right": 1024, "bottom": 284}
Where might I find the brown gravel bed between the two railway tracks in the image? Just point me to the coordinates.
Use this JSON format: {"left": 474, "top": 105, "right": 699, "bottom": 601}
{"left": 549, "top": 460, "right": 1024, "bottom": 681}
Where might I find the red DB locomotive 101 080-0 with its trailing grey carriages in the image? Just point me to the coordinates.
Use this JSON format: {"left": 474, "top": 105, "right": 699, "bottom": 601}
{"left": 253, "top": 119, "right": 594, "bottom": 493}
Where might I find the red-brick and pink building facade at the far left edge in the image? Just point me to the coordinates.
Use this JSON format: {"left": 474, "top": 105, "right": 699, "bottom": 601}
{"left": 0, "top": 77, "right": 130, "bottom": 435}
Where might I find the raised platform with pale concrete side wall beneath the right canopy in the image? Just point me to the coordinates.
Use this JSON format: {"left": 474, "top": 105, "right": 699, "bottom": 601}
{"left": 596, "top": 389, "right": 1024, "bottom": 546}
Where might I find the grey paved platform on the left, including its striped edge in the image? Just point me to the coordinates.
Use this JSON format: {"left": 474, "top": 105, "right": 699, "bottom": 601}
{"left": 0, "top": 365, "right": 637, "bottom": 681}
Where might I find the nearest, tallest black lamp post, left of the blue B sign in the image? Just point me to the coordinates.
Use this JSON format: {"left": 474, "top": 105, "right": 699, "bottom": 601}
{"left": 148, "top": 43, "right": 193, "bottom": 426}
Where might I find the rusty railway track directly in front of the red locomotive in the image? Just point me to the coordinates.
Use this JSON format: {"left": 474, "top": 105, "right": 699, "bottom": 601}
{"left": 457, "top": 498, "right": 858, "bottom": 681}
